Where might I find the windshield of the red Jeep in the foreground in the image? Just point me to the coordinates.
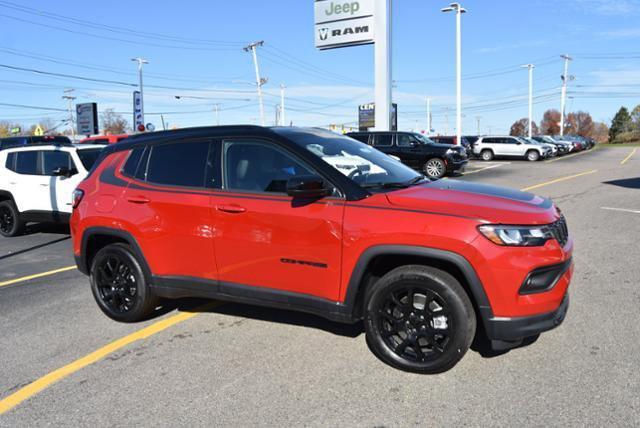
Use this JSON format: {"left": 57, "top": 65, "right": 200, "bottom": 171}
{"left": 274, "top": 128, "right": 422, "bottom": 187}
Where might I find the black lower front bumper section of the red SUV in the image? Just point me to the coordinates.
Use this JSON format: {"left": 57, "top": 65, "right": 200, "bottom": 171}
{"left": 485, "top": 294, "right": 569, "bottom": 341}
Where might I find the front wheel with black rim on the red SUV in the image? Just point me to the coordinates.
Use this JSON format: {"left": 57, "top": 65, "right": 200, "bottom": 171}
{"left": 364, "top": 265, "right": 476, "bottom": 374}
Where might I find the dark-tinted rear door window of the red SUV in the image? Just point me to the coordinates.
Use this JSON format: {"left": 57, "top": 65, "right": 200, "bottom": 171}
{"left": 147, "top": 141, "right": 209, "bottom": 187}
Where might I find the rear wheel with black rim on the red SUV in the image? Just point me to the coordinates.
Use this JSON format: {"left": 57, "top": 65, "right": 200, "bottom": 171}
{"left": 90, "top": 244, "right": 158, "bottom": 322}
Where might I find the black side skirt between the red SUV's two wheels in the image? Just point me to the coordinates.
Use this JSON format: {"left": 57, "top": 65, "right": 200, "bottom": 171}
{"left": 151, "top": 276, "right": 356, "bottom": 324}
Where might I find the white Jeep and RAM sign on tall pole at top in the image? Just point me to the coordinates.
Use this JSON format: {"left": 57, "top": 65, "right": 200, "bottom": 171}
{"left": 315, "top": 0, "right": 374, "bottom": 49}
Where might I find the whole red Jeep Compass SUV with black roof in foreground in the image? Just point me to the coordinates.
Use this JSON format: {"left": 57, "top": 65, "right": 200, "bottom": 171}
{"left": 71, "top": 126, "right": 573, "bottom": 373}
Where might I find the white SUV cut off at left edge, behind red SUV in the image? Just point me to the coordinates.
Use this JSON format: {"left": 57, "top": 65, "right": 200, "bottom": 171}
{"left": 0, "top": 144, "right": 104, "bottom": 236}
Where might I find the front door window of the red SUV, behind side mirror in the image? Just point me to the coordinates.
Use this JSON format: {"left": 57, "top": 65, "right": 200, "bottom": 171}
{"left": 224, "top": 141, "right": 313, "bottom": 193}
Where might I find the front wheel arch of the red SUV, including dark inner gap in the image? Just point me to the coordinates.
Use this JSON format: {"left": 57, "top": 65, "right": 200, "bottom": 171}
{"left": 345, "top": 245, "right": 493, "bottom": 326}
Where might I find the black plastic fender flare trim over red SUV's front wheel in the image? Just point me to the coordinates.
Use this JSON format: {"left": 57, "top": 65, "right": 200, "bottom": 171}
{"left": 344, "top": 245, "right": 493, "bottom": 325}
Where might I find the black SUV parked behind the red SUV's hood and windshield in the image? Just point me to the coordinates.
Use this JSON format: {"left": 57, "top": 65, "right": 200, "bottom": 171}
{"left": 347, "top": 132, "right": 468, "bottom": 178}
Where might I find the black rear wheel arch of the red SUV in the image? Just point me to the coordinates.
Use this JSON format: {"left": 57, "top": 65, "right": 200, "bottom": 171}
{"left": 76, "top": 227, "right": 152, "bottom": 281}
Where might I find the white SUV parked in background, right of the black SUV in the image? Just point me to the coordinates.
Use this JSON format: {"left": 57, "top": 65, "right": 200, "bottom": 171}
{"left": 473, "top": 136, "right": 552, "bottom": 161}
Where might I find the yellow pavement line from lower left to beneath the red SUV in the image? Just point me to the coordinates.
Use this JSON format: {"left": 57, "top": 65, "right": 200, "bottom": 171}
{"left": 0, "top": 302, "right": 220, "bottom": 415}
